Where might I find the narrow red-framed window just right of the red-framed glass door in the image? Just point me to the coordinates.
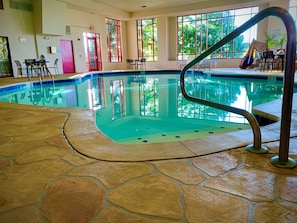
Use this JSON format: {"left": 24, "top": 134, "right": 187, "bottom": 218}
{"left": 105, "top": 18, "right": 123, "bottom": 63}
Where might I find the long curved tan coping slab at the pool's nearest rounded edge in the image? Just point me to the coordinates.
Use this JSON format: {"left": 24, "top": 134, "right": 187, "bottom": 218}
{"left": 68, "top": 132, "right": 194, "bottom": 161}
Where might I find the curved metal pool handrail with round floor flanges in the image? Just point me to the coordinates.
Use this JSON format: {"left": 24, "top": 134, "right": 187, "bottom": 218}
{"left": 180, "top": 7, "right": 296, "bottom": 168}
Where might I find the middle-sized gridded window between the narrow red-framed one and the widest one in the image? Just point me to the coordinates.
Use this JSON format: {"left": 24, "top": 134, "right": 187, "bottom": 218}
{"left": 137, "top": 18, "right": 158, "bottom": 61}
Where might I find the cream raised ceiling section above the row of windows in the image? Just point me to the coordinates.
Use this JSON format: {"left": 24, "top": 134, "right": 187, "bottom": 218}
{"left": 56, "top": 0, "right": 280, "bottom": 20}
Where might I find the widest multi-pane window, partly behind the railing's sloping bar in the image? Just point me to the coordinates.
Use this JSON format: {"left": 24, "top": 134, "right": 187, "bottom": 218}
{"left": 177, "top": 7, "right": 259, "bottom": 60}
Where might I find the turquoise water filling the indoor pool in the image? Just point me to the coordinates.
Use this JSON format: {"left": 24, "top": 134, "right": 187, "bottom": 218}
{"left": 0, "top": 71, "right": 290, "bottom": 144}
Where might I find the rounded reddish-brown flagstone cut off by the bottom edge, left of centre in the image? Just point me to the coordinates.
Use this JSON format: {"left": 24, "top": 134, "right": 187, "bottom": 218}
{"left": 41, "top": 178, "right": 105, "bottom": 223}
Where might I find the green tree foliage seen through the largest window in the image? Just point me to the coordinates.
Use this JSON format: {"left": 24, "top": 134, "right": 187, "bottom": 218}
{"left": 178, "top": 11, "right": 249, "bottom": 58}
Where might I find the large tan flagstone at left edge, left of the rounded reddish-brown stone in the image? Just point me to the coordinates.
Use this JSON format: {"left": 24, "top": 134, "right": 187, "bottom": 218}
{"left": 0, "top": 160, "right": 70, "bottom": 211}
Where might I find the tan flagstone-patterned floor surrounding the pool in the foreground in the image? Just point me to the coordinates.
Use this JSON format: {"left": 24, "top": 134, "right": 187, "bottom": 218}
{"left": 0, "top": 71, "right": 297, "bottom": 223}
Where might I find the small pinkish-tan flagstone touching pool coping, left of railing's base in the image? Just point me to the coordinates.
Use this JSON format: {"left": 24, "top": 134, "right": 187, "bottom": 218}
{"left": 193, "top": 152, "right": 240, "bottom": 176}
